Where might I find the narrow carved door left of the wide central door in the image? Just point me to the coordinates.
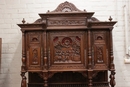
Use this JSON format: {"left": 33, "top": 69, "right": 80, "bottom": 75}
{"left": 26, "top": 32, "right": 42, "bottom": 70}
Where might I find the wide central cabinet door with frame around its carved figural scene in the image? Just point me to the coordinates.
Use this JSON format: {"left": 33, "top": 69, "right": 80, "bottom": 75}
{"left": 49, "top": 31, "right": 85, "bottom": 69}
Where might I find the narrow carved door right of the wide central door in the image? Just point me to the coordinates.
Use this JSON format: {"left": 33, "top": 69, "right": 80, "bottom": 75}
{"left": 92, "top": 30, "right": 109, "bottom": 69}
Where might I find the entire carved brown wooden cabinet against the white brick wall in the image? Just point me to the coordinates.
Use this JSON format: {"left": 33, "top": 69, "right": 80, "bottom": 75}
{"left": 18, "top": 1, "right": 116, "bottom": 87}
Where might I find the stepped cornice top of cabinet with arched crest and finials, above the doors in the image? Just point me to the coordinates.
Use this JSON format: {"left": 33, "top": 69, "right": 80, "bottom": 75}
{"left": 18, "top": 1, "right": 116, "bottom": 30}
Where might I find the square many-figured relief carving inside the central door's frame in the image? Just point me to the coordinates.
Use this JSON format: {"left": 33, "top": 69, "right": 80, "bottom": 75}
{"left": 53, "top": 36, "right": 81, "bottom": 63}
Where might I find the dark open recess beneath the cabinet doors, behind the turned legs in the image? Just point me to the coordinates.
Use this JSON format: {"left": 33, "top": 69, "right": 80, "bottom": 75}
{"left": 28, "top": 71, "right": 110, "bottom": 87}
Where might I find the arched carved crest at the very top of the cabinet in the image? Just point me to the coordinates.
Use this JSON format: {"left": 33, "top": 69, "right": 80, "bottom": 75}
{"left": 49, "top": 1, "right": 81, "bottom": 12}
